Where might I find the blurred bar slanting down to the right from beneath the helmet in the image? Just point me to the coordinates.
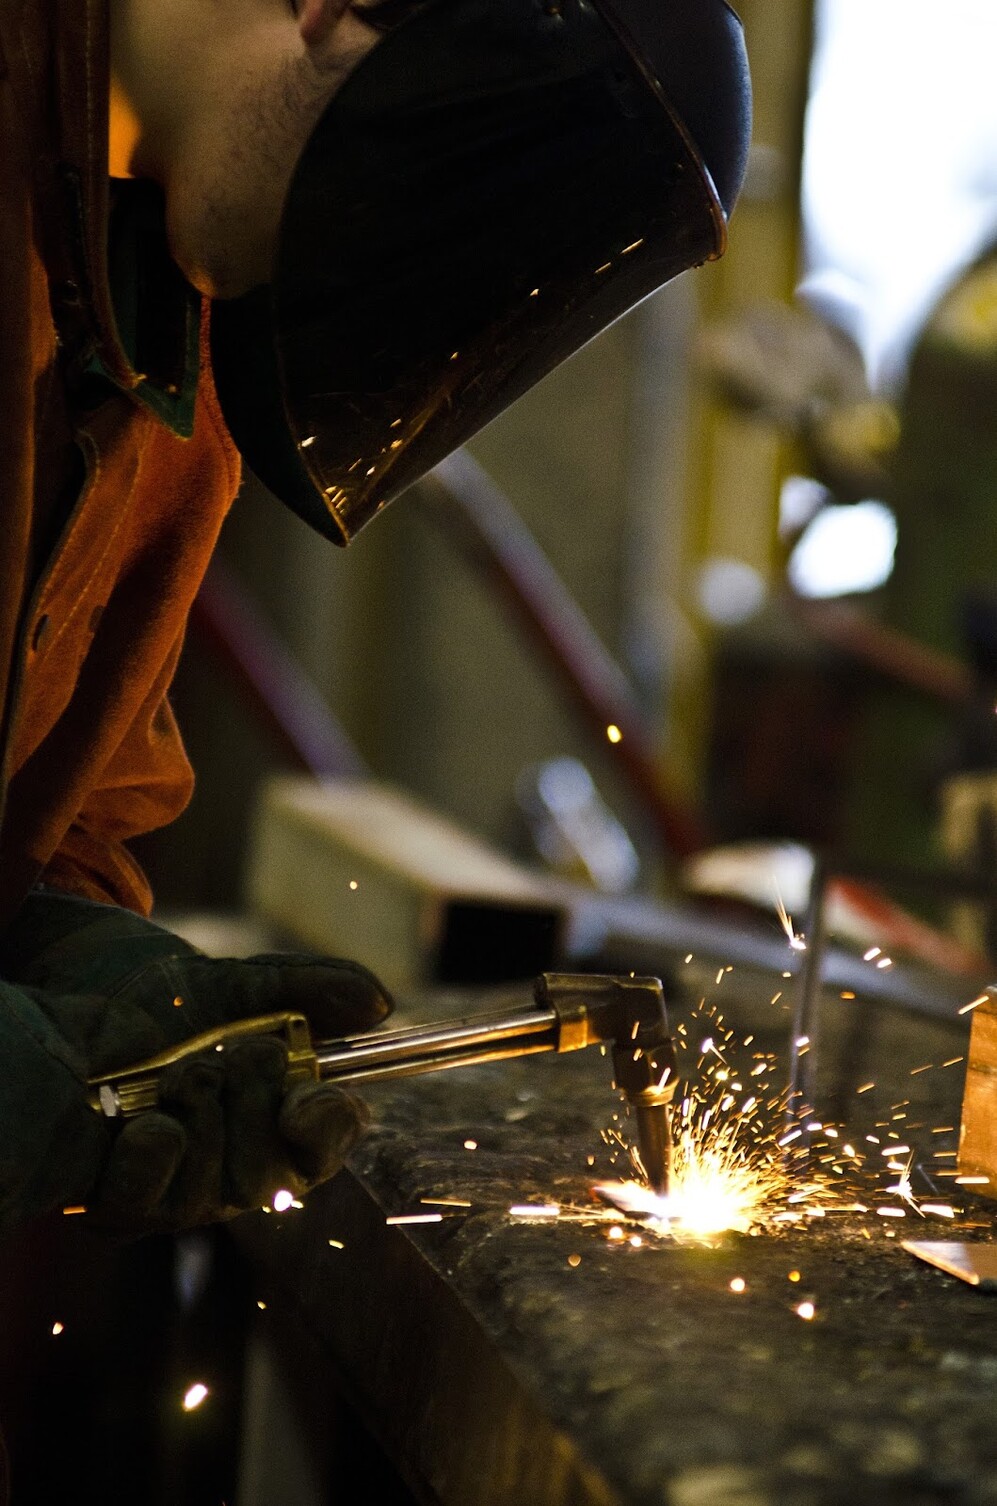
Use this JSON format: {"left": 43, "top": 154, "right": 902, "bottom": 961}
{"left": 414, "top": 450, "right": 706, "bottom": 858}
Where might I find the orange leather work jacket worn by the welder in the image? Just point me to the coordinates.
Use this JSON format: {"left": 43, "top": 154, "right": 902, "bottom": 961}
{"left": 0, "top": 0, "right": 239, "bottom": 922}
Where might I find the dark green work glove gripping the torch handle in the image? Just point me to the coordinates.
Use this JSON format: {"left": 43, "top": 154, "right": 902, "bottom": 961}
{"left": 0, "top": 890, "right": 392, "bottom": 1233}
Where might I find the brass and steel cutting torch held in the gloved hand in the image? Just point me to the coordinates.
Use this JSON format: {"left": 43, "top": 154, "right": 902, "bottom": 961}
{"left": 90, "top": 973, "right": 676, "bottom": 1194}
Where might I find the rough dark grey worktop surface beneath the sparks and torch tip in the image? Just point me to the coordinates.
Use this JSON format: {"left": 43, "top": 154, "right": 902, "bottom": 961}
{"left": 236, "top": 981, "right": 997, "bottom": 1506}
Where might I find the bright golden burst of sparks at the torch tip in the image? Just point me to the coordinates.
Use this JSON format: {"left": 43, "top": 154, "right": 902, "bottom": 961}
{"left": 368, "top": 970, "right": 986, "bottom": 1246}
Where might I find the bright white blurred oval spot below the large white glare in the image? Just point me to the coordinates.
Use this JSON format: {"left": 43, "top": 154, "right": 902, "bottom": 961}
{"left": 786, "top": 501, "right": 896, "bottom": 598}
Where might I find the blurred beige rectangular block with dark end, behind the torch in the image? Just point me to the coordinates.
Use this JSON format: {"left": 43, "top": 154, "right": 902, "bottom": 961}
{"left": 248, "top": 777, "right": 569, "bottom": 989}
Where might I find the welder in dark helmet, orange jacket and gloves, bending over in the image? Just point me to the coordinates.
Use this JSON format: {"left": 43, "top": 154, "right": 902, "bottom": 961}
{"left": 0, "top": 0, "right": 749, "bottom": 1232}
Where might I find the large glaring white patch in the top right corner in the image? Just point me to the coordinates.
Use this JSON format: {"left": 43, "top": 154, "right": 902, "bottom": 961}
{"left": 803, "top": 0, "right": 997, "bottom": 390}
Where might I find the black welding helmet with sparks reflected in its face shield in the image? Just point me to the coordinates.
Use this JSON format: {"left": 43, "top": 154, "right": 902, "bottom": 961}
{"left": 211, "top": 0, "right": 750, "bottom": 544}
